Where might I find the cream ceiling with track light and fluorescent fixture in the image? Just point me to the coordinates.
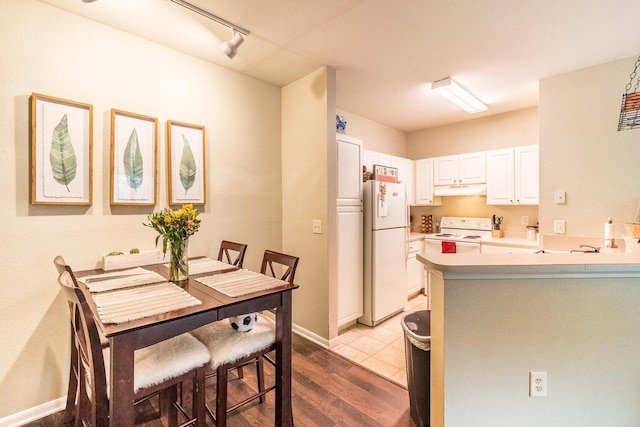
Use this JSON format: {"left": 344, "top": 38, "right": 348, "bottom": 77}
{"left": 40, "top": 0, "right": 640, "bottom": 131}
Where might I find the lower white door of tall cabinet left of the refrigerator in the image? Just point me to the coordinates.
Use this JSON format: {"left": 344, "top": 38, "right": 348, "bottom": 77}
{"left": 337, "top": 206, "right": 364, "bottom": 327}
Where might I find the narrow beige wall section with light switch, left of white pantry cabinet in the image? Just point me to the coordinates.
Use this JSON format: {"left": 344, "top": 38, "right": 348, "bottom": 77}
{"left": 282, "top": 67, "right": 337, "bottom": 343}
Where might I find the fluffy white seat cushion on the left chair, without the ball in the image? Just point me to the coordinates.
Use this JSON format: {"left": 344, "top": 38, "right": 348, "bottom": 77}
{"left": 103, "top": 334, "right": 209, "bottom": 392}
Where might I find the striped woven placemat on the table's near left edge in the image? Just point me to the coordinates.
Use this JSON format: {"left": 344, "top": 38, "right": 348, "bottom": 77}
{"left": 93, "top": 282, "right": 202, "bottom": 323}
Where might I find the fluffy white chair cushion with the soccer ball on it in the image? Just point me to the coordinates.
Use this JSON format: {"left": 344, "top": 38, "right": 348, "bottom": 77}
{"left": 191, "top": 314, "right": 275, "bottom": 369}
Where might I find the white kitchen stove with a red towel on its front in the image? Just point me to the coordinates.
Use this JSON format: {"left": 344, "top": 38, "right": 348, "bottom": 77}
{"left": 424, "top": 216, "right": 492, "bottom": 254}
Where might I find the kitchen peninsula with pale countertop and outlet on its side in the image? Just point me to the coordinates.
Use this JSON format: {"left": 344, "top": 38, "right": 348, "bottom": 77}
{"left": 417, "top": 253, "right": 640, "bottom": 426}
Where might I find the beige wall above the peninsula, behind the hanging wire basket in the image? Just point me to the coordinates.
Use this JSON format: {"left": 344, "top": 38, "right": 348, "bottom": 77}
{"left": 540, "top": 57, "right": 640, "bottom": 238}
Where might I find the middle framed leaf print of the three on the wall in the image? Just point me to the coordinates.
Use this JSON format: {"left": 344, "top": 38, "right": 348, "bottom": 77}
{"left": 111, "top": 109, "right": 158, "bottom": 206}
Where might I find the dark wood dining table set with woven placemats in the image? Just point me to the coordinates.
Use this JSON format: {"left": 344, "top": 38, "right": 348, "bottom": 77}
{"left": 76, "top": 264, "right": 298, "bottom": 427}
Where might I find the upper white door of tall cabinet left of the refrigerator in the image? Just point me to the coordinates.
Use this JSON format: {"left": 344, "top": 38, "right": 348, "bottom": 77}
{"left": 336, "top": 134, "right": 362, "bottom": 205}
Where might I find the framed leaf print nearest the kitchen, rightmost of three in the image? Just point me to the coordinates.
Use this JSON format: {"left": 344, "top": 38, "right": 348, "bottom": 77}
{"left": 167, "top": 120, "right": 206, "bottom": 205}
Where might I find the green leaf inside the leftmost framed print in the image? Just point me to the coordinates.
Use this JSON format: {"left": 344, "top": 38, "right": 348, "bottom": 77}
{"left": 49, "top": 114, "right": 78, "bottom": 192}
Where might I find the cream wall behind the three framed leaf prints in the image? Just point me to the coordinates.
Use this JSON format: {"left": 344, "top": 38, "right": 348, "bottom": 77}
{"left": 0, "top": 0, "right": 280, "bottom": 419}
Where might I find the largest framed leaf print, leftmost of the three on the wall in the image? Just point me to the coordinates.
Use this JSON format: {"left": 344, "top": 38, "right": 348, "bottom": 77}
{"left": 31, "top": 93, "right": 93, "bottom": 205}
